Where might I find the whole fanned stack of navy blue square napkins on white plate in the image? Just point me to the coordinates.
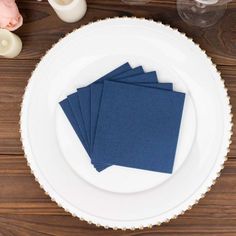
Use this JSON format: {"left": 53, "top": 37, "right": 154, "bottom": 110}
{"left": 60, "top": 63, "right": 185, "bottom": 173}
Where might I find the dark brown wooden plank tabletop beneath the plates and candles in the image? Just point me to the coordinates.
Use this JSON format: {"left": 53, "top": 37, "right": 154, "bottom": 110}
{"left": 0, "top": 0, "right": 236, "bottom": 236}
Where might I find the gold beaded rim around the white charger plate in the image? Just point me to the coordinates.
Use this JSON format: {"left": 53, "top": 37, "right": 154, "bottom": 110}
{"left": 19, "top": 17, "right": 233, "bottom": 230}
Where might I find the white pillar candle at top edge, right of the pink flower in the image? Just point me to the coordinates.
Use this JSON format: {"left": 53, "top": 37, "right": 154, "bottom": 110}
{"left": 48, "top": 0, "right": 87, "bottom": 23}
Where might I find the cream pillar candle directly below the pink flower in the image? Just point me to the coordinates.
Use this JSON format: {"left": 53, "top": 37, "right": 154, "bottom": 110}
{"left": 0, "top": 29, "right": 22, "bottom": 58}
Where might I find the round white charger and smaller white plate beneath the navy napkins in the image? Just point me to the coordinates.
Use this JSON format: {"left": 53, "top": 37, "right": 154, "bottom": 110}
{"left": 21, "top": 18, "right": 232, "bottom": 229}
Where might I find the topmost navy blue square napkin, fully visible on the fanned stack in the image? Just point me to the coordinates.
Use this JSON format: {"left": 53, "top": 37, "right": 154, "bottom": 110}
{"left": 92, "top": 81, "right": 185, "bottom": 173}
